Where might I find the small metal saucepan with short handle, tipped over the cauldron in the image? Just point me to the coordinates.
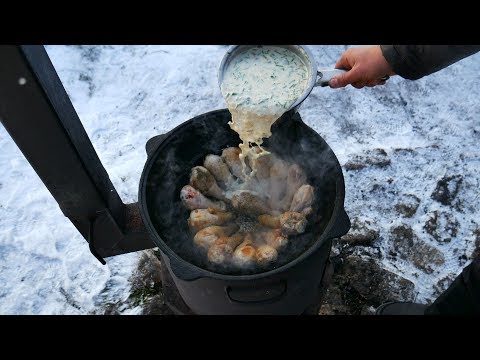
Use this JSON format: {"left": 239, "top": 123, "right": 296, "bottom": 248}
{"left": 218, "top": 45, "right": 345, "bottom": 111}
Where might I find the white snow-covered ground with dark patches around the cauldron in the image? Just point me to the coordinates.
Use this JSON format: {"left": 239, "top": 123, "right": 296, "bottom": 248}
{"left": 0, "top": 46, "right": 480, "bottom": 314}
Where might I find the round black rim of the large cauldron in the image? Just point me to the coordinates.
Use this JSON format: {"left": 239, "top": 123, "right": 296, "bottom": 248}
{"left": 138, "top": 108, "right": 350, "bottom": 281}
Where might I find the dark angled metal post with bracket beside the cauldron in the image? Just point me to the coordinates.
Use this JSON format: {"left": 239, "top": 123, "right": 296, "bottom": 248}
{"left": 0, "top": 45, "right": 155, "bottom": 264}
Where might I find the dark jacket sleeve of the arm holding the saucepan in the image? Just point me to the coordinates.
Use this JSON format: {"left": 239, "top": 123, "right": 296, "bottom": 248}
{"left": 380, "top": 45, "right": 480, "bottom": 80}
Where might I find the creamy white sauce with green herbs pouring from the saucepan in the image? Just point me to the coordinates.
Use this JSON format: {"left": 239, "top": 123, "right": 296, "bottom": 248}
{"left": 221, "top": 46, "right": 310, "bottom": 175}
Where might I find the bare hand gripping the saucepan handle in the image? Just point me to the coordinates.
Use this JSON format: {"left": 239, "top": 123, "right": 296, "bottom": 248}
{"left": 329, "top": 46, "right": 395, "bottom": 89}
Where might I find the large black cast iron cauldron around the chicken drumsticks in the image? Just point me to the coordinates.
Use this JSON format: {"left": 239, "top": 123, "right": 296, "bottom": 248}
{"left": 139, "top": 109, "right": 350, "bottom": 314}
